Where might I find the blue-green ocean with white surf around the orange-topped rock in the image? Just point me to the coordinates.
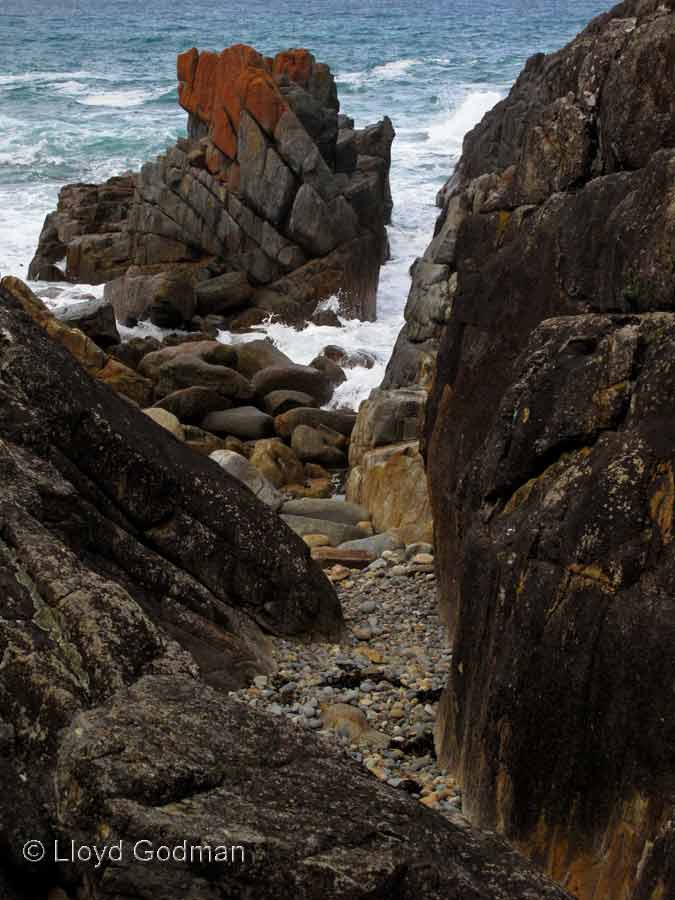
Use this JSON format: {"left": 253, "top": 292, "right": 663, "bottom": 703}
{"left": 0, "top": 0, "right": 612, "bottom": 405}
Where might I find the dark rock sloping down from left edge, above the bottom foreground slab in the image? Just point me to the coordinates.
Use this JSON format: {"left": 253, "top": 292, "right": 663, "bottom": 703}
{"left": 0, "top": 279, "right": 342, "bottom": 884}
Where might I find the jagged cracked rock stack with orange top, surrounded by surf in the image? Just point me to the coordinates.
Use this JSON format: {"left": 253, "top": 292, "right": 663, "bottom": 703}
{"left": 29, "top": 45, "right": 394, "bottom": 328}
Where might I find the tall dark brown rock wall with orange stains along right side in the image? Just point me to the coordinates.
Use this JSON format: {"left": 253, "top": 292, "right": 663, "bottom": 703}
{"left": 410, "top": 0, "right": 675, "bottom": 900}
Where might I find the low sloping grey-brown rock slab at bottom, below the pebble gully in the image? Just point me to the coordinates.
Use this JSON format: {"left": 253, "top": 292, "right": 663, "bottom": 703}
{"left": 56, "top": 676, "right": 580, "bottom": 900}
